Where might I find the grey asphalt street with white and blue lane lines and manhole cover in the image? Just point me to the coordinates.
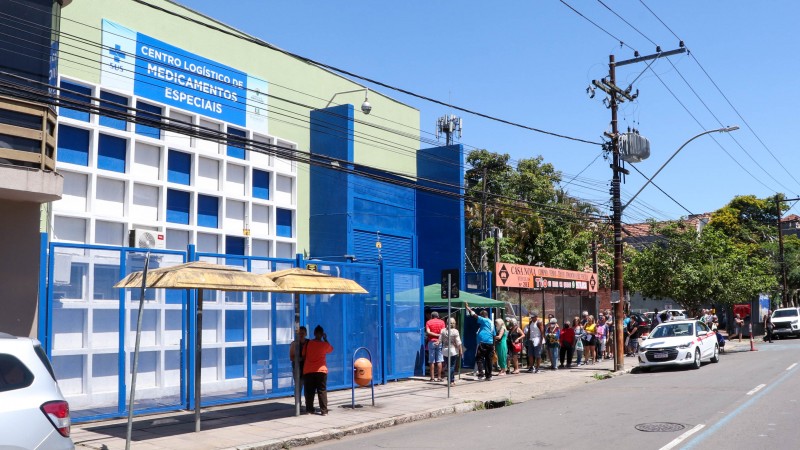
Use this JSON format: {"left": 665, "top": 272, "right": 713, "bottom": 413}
{"left": 313, "top": 339, "right": 800, "bottom": 449}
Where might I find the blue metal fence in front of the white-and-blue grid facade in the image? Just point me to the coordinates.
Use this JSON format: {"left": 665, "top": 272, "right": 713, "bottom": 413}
{"left": 39, "top": 239, "right": 423, "bottom": 422}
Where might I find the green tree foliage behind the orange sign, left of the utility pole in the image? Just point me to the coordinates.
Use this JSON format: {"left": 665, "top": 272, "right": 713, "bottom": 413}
{"left": 465, "top": 150, "right": 608, "bottom": 284}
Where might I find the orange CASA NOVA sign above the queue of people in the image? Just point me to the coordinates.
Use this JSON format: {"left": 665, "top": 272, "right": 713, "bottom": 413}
{"left": 495, "top": 263, "right": 597, "bottom": 292}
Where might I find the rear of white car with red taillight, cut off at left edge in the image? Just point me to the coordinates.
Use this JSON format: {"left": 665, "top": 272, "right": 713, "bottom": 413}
{"left": 0, "top": 333, "right": 75, "bottom": 449}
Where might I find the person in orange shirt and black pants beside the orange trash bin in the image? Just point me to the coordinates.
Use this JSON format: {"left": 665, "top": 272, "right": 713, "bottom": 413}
{"left": 303, "top": 325, "right": 333, "bottom": 416}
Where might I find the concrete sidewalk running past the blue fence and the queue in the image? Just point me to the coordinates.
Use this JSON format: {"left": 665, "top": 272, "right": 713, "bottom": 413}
{"left": 72, "top": 340, "right": 750, "bottom": 450}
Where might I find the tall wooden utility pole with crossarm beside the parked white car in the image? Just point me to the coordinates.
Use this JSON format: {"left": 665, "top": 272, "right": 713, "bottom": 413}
{"left": 592, "top": 42, "right": 686, "bottom": 371}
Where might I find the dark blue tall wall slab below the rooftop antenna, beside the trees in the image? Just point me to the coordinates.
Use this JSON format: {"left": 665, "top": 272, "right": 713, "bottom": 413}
{"left": 416, "top": 144, "right": 466, "bottom": 289}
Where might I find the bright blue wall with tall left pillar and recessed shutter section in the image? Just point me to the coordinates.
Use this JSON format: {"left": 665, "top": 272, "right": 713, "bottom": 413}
{"left": 309, "top": 105, "right": 417, "bottom": 267}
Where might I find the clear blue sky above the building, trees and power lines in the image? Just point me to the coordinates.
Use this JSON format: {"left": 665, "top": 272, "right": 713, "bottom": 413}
{"left": 178, "top": 0, "right": 800, "bottom": 223}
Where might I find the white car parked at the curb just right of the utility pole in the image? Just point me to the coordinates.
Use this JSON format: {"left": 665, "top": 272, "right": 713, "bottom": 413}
{"left": 637, "top": 320, "right": 719, "bottom": 370}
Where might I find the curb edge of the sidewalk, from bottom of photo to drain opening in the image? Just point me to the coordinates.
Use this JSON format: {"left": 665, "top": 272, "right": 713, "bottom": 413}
{"left": 229, "top": 399, "right": 488, "bottom": 450}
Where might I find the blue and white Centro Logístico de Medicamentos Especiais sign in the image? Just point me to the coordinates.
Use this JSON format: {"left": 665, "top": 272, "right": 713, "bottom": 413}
{"left": 101, "top": 19, "right": 268, "bottom": 133}
